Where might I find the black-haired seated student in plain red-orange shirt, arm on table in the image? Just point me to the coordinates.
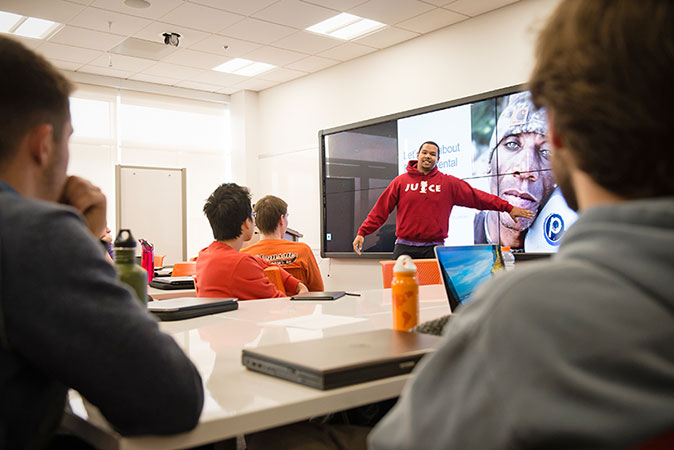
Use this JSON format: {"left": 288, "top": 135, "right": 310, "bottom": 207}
{"left": 196, "top": 183, "right": 307, "bottom": 300}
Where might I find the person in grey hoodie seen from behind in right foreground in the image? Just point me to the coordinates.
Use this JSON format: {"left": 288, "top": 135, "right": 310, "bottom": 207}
{"left": 369, "top": 0, "right": 674, "bottom": 450}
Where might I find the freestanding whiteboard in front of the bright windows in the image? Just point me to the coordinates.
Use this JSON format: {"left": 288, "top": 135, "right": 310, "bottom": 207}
{"left": 115, "top": 165, "right": 187, "bottom": 265}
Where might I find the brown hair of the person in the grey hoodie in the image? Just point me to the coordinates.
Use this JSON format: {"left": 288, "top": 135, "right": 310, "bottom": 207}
{"left": 529, "top": 0, "right": 674, "bottom": 198}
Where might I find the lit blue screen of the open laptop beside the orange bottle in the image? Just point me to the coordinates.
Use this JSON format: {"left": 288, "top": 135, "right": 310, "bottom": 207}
{"left": 435, "top": 244, "right": 503, "bottom": 311}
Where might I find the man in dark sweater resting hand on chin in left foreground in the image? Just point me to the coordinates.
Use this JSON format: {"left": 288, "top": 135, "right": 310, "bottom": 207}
{"left": 0, "top": 36, "right": 203, "bottom": 449}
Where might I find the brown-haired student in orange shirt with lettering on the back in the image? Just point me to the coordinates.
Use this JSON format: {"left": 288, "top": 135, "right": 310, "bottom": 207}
{"left": 241, "top": 195, "right": 324, "bottom": 292}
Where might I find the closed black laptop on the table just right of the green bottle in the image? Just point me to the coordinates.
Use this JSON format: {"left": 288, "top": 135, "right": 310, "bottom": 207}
{"left": 147, "top": 297, "right": 239, "bottom": 321}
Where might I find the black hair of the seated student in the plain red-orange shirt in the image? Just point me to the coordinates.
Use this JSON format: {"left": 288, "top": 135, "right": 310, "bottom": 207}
{"left": 204, "top": 183, "right": 253, "bottom": 241}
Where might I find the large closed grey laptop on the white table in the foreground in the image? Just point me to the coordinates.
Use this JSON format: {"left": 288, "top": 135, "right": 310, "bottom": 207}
{"left": 241, "top": 329, "right": 440, "bottom": 389}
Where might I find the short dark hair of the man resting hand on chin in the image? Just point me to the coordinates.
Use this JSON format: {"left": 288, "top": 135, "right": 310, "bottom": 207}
{"left": 0, "top": 35, "right": 72, "bottom": 167}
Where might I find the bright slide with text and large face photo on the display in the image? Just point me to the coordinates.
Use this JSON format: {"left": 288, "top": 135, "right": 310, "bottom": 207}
{"left": 398, "top": 91, "right": 576, "bottom": 252}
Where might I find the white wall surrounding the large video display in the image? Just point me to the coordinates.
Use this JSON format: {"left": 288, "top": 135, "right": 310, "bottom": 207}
{"left": 231, "top": 0, "right": 557, "bottom": 289}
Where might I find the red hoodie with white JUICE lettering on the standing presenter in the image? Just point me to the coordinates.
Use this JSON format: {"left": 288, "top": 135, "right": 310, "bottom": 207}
{"left": 358, "top": 160, "right": 513, "bottom": 242}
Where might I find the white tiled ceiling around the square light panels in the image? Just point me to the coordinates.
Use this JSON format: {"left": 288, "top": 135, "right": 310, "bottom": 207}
{"left": 0, "top": 0, "right": 519, "bottom": 94}
